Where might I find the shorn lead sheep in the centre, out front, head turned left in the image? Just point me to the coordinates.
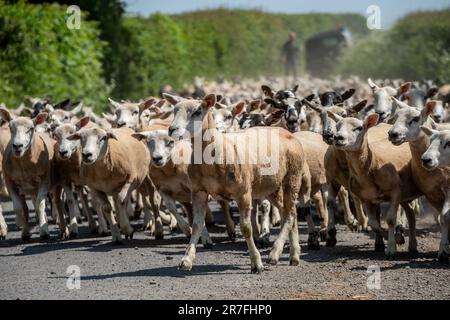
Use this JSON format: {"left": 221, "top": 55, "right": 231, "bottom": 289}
{"left": 165, "top": 94, "right": 310, "bottom": 273}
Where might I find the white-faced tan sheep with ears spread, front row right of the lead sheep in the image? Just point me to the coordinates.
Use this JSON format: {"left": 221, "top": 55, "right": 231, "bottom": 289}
{"left": 329, "top": 112, "right": 420, "bottom": 258}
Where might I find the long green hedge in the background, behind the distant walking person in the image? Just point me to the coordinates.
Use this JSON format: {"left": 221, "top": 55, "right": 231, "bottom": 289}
{"left": 113, "top": 9, "right": 367, "bottom": 99}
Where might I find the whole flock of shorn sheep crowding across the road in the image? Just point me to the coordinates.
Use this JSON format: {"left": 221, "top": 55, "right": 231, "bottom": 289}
{"left": 0, "top": 78, "right": 450, "bottom": 273}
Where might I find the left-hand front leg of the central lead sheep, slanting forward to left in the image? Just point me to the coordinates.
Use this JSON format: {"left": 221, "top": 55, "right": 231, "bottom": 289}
{"left": 178, "top": 191, "right": 208, "bottom": 271}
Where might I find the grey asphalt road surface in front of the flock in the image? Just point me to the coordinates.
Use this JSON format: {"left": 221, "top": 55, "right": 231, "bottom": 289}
{"left": 0, "top": 198, "right": 450, "bottom": 299}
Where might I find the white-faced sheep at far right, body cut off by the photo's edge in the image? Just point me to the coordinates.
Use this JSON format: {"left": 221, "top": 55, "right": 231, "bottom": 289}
{"left": 420, "top": 126, "right": 450, "bottom": 262}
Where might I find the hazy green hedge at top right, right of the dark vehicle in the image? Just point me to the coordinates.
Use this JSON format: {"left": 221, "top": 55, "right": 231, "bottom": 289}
{"left": 338, "top": 9, "right": 450, "bottom": 83}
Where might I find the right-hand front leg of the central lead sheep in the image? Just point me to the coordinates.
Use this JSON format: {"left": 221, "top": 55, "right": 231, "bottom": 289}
{"left": 237, "top": 194, "right": 264, "bottom": 273}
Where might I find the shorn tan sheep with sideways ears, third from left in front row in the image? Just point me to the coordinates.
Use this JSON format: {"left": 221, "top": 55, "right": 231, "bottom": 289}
{"left": 67, "top": 121, "right": 150, "bottom": 243}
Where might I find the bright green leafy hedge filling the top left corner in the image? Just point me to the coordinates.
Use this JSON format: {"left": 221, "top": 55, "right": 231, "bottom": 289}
{"left": 0, "top": 1, "right": 109, "bottom": 108}
